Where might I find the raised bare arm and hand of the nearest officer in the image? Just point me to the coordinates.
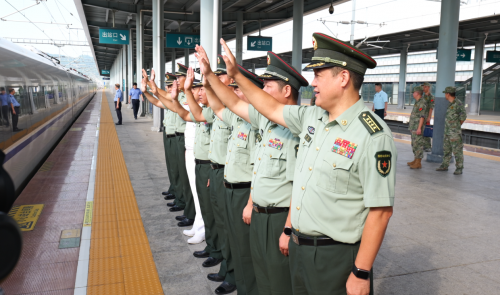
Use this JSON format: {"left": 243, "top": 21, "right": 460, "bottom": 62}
{"left": 221, "top": 38, "right": 288, "bottom": 127}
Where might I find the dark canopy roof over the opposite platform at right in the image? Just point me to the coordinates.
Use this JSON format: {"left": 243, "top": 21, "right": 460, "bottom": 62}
{"left": 243, "top": 15, "right": 500, "bottom": 68}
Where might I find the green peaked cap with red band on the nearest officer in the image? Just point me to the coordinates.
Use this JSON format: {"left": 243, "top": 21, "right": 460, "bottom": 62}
{"left": 304, "top": 33, "right": 377, "bottom": 75}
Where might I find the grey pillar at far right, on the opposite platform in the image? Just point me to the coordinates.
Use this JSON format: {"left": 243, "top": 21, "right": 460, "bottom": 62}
{"left": 469, "top": 35, "right": 485, "bottom": 115}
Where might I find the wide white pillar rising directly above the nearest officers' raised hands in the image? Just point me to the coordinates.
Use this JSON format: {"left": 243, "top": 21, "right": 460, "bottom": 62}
{"left": 200, "top": 0, "right": 219, "bottom": 70}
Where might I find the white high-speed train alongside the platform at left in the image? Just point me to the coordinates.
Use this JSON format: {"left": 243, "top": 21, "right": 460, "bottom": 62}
{"left": 0, "top": 38, "right": 97, "bottom": 192}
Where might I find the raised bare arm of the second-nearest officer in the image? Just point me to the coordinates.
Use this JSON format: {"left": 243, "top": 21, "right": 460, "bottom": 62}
{"left": 195, "top": 45, "right": 250, "bottom": 123}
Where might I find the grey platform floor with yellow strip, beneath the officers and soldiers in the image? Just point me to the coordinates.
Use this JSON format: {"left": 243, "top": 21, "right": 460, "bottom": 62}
{"left": 1, "top": 92, "right": 500, "bottom": 295}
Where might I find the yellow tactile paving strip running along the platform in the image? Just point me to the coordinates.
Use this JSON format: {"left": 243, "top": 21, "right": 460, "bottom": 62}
{"left": 87, "top": 91, "right": 163, "bottom": 295}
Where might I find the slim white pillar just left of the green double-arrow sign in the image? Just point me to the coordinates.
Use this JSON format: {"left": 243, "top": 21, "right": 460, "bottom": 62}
{"left": 151, "top": 0, "right": 165, "bottom": 132}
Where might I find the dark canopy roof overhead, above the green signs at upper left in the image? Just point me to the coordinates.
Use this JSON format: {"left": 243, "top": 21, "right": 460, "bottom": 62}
{"left": 74, "top": 0, "right": 348, "bottom": 72}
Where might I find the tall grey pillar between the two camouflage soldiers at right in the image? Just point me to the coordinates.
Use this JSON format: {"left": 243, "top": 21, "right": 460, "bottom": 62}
{"left": 427, "top": 0, "right": 460, "bottom": 163}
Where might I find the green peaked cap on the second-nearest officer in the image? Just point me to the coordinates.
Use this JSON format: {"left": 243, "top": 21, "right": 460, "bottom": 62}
{"left": 258, "top": 51, "right": 309, "bottom": 90}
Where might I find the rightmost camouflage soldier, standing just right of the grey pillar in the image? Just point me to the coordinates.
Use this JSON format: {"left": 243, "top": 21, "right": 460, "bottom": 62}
{"left": 436, "top": 87, "right": 467, "bottom": 175}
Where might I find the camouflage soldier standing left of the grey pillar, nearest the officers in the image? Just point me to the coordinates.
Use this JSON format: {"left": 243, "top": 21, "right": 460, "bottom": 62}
{"left": 407, "top": 86, "right": 428, "bottom": 169}
